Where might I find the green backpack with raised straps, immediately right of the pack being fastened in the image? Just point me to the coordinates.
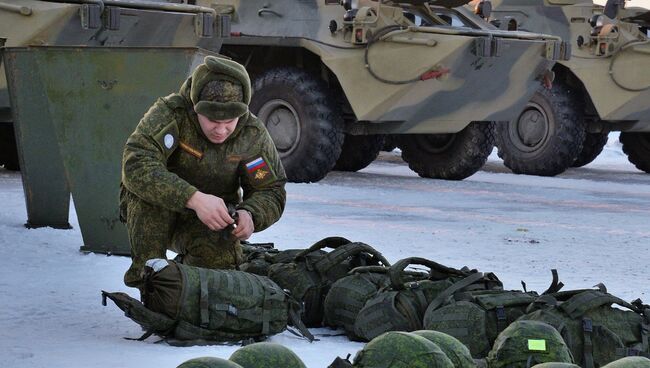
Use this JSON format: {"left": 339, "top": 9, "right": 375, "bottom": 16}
{"left": 269, "top": 237, "right": 390, "bottom": 327}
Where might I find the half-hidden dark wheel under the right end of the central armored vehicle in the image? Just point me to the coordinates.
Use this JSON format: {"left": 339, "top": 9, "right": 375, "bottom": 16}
{"left": 397, "top": 122, "right": 494, "bottom": 180}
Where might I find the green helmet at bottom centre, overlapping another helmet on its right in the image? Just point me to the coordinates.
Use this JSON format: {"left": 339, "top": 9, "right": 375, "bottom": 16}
{"left": 352, "top": 331, "right": 454, "bottom": 368}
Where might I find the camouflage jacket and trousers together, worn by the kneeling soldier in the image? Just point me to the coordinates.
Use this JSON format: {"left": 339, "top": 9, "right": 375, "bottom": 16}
{"left": 120, "top": 69, "right": 286, "bottom": 286}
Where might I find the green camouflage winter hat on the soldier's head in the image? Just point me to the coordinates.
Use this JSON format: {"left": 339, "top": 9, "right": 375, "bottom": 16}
{"left": 190, "top": 56, "right": 251, "bottom": 120}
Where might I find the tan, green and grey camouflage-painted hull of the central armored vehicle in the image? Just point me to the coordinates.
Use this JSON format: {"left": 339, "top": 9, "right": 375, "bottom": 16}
{"left": 209, "top": 0, "right": 559, "bottom": 134}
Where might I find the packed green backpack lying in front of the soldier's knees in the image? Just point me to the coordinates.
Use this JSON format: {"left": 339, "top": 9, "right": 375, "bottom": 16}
{"left": 102, "top": 259, "right": 313, "bottom": 346}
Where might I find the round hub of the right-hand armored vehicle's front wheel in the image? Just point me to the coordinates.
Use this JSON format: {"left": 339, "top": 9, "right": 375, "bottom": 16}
{"left": 509, "top": 102, "right": 549, "bottom": 152}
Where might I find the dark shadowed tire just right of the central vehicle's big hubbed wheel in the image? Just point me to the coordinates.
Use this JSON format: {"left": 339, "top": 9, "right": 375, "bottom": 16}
{"left": 334, "top": 134, "right": 386, "bottom": 171}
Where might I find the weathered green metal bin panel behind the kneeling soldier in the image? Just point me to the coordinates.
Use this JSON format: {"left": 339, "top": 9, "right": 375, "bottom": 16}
{"left": 5, "top": 47, "right": 216, "bottom": 254}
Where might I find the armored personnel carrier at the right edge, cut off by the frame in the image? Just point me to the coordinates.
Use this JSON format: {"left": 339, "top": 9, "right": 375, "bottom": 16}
{"left": 492, "top": 0, "right": 650, "bottom": 176}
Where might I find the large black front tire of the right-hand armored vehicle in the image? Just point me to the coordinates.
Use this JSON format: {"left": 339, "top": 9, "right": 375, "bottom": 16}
{"left": 496, "top": 82, "right": 586, "bottom": 176}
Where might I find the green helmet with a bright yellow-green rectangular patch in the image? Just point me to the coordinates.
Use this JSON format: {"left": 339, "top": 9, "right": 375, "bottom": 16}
{"left": 487, "top": 321, "right": 573, "bottom": 368}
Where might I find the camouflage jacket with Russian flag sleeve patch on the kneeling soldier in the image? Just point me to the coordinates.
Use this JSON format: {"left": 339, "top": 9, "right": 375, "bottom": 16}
{"left": 122, "top": 79, "right": 286, "bottom": 232}
